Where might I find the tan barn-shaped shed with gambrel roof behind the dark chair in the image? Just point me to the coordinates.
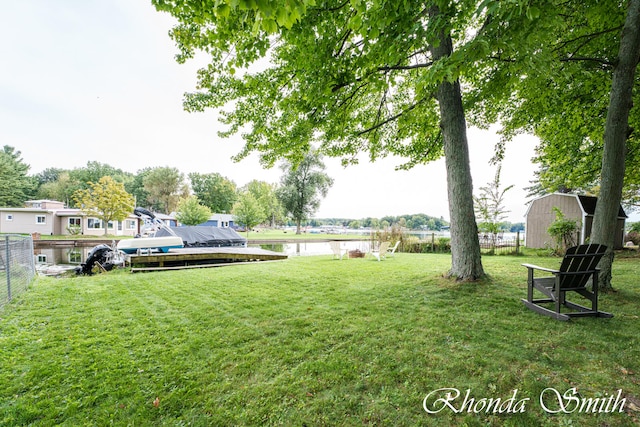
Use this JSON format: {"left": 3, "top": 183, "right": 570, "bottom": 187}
{"left": 525, "top": 193, "right": 627, "bottom": 249}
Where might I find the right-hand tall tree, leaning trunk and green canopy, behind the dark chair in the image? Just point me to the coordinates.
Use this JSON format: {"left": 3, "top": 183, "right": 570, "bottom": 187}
{"left": 470, "top": 0, "right": 640, "bottom": 289}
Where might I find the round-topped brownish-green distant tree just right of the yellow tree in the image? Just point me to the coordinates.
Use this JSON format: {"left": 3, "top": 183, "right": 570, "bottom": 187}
{"left": 143, "top": 166, "right": 189, "bottom": 214}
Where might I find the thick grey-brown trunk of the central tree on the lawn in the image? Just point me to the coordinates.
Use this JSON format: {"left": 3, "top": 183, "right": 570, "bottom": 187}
{"left": 431, "top": 8, "right": 484, "bottom": 280}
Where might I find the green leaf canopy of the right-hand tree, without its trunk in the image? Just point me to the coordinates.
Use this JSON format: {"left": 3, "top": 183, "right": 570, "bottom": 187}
{"left": 469, "top": 0, "right": 640, "bottom": 207}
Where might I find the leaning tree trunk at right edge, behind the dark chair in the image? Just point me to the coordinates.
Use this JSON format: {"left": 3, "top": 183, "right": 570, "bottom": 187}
{"left": 591, "top": 0, "right": 640, "bottom": 290}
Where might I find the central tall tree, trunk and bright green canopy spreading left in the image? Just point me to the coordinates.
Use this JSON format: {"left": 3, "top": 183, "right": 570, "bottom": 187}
{"left": 153, "top": 0, "right": 487, "bottom": 280}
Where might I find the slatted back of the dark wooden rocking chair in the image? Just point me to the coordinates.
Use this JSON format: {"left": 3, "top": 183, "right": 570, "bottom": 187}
{"left": 560, "top": 243, "right": 607, "bottom": 288}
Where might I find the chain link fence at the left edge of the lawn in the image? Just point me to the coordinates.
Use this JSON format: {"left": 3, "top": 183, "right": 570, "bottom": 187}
{"left": 0, "top": 234, "right": 36, "bottom": 309}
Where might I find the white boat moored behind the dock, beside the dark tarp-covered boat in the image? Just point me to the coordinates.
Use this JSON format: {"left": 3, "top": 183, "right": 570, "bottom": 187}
{"left": 117, "top": 208, "right": 184, "bottom": 254}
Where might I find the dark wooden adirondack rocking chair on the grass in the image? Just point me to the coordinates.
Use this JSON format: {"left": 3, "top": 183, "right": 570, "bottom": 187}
{"left": 522, "top": 243, "right": 613, "bottom": 320}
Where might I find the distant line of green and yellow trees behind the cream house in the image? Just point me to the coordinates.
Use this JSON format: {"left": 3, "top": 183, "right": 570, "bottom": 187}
{"left": 0, "top": 146, "right": 340, "bottom": 234}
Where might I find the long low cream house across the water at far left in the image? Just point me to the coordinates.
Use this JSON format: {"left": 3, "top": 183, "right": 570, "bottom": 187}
{"left": 0, "top": 200, "right": 138, "bottom": 236}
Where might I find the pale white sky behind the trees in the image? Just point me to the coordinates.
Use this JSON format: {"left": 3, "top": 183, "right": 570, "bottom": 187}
{"left": 0, "top": 0, "right": 552, "bottom": 222}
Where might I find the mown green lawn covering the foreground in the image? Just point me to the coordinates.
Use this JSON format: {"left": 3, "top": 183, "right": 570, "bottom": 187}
{"left": 0, "top": 254, "right": 640, "bottom": 426}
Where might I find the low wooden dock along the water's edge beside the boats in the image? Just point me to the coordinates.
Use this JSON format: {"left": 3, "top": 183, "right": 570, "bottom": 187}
{"left": 128, "top": 247, "right": 288, "bottom": 273}
